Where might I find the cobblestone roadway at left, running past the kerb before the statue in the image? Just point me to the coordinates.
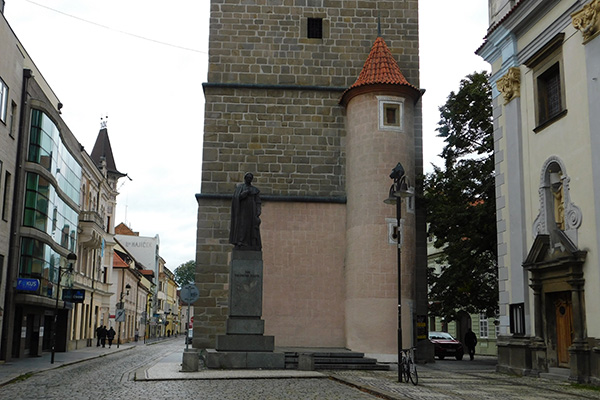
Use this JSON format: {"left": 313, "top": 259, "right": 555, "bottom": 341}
{"left": 0, "top": 341, "right": 374, "bottom": 400}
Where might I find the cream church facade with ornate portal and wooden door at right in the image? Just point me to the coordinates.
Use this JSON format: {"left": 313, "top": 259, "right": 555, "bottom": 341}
{"left": 477, "top": 0, "right": 600, "bottom": 383}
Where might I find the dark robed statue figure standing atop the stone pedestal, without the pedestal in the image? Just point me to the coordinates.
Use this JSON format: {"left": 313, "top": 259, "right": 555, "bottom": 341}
{"left": 229, "top": 172, "right": 262, "bottom": 251}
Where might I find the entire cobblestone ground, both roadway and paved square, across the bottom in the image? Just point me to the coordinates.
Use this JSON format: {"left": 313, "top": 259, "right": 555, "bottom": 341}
{"left": 0, "top": 340, "right": 600, "bottom": 400}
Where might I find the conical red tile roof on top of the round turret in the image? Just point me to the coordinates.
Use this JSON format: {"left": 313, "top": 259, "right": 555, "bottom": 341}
{"left": 340, "top": 37, "right": 419, "bottom": 103}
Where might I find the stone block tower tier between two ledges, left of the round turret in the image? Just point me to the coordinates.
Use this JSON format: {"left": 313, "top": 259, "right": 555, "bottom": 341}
{"left": 202, "top": 87, "right": 345, "bottom": 196}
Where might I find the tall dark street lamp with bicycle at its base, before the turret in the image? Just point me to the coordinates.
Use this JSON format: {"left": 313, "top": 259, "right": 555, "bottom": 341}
{"left": 383, "top": 163, "right": 413, "bottom": 382}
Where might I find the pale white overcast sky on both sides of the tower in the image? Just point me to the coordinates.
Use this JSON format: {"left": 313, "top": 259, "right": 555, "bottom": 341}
{"left": 4, "top": 0, "right": 489, "bottom": 271}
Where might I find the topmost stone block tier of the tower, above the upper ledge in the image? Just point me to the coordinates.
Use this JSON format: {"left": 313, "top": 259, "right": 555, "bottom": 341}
{"left": 208, "top": 0, "right": 419, "bottom": 87}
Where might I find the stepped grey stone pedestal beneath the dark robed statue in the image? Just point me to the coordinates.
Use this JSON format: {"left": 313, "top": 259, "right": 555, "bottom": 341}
{"left": 203, "top": 249, "right": 285, "bottom": 369}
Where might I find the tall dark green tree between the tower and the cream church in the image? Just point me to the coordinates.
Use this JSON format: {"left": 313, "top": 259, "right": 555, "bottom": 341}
{"left": 424, "top": 72, "right": 498, "bottom": 321}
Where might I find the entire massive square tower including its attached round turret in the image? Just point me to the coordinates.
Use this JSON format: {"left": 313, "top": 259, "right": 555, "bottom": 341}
{"left": 193, "top": 0, "right": 427, "bottom": 359}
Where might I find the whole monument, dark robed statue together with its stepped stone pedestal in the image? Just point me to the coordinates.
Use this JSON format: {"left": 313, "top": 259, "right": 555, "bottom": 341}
{"left": 204, "top": 173, "right": 285, "bottom": 369}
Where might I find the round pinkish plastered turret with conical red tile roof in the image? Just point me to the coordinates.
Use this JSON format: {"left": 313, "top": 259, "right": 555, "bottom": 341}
{"left": 341, "top": 37, "right": 421, "bottom": 352}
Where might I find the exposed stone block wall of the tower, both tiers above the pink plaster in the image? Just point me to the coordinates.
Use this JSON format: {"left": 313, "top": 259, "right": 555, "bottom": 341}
{"left": 202, "top": 0, "right": 419, "bottom": 196}
